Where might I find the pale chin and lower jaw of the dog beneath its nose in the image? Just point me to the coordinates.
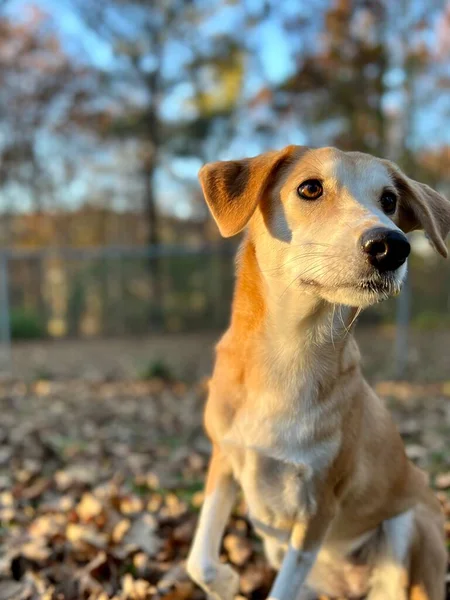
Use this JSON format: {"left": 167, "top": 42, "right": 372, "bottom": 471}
{"left": 305, "top": 269, "right": 406, "bottom": 308}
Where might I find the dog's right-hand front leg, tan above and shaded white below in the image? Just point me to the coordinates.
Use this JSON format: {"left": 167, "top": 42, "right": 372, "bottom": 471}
{"left": 268, "top": 499, "right": 335, "bottom": 600}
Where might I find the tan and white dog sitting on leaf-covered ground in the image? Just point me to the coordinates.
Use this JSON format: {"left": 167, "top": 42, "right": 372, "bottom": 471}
{"left": 187, "top": 146, "right": 450, "bottom": 600}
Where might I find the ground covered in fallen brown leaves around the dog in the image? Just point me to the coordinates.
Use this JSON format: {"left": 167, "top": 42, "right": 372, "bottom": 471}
{"left": 0, "top": 379, "right": 450, "bottom": 600}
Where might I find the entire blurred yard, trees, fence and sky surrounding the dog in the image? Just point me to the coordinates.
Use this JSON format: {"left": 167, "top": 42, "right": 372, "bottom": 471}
{"left": 0, "top": 0, "right": 450, "bottom": 600}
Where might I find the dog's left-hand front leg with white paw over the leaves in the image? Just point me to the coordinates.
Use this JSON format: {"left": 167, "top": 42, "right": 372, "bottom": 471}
{"left": 187, "top": 447, "right": 239, "bottom": 600}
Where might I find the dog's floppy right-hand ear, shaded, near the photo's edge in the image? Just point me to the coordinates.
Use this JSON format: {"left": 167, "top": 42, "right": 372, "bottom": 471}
{"left": 389, "top": 162, "right": 450, "bottom": 258}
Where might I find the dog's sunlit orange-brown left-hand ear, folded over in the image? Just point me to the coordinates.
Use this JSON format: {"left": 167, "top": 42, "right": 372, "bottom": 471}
{"left": 199, "top": 146, "right": 299, "bottom": 237}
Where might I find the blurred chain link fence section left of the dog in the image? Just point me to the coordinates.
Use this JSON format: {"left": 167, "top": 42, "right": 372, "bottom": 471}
{"left": 0, "top": 246, "right": 234, "bottom": 340}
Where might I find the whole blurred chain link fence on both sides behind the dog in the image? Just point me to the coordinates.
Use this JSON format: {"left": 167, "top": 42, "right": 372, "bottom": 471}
{"left": 0, "top": 243, "right": 450, "bottom": 370}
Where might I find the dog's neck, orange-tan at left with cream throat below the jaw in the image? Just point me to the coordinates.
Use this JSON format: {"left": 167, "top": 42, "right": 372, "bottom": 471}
{"left": 230, "top": 238, "right": 355, "bottom": 396}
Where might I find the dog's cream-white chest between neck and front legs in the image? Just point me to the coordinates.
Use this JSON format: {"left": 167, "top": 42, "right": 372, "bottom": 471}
{"left": 222, "top": 399, "right": 340, "bottom": 535}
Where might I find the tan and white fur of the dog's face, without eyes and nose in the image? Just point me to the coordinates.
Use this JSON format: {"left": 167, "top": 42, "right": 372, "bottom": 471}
{"left": 250, "top": 148, "right": 406, "bottom": 307}
